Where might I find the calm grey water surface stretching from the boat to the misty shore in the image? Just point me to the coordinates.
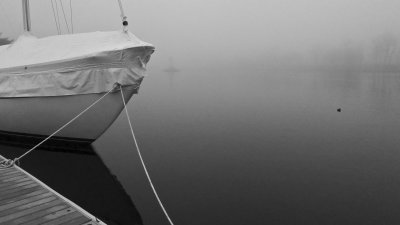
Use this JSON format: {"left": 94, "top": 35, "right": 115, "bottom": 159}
{"left": 3, "top": 71, "right": 400, "bottom": 225}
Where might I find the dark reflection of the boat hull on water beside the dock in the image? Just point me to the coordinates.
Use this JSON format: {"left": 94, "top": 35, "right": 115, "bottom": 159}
{"left": 0, "top": 138, "right": 143, "bottom": 225}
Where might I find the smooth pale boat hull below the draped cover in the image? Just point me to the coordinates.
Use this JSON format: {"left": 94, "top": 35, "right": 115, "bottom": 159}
{"left": 0, "top": 86, "right": 137, "bottom": 143}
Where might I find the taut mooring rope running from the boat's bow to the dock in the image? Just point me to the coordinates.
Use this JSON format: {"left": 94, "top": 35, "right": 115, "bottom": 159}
{"left": 0, "top": 86, "right": 118, "bottom": 170}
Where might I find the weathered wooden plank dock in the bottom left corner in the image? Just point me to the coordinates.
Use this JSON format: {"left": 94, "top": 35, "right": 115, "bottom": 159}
{"left": 0, "top": 156, "right": 105, "bottom": 225}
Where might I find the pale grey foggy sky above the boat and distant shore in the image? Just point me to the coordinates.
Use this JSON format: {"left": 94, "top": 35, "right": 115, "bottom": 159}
{"left": 0, "top": 0, "right": 400, "bottom": 67}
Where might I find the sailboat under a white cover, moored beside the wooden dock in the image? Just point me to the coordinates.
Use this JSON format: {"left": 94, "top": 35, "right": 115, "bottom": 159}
{"left": 0, "top": 0, "right": 154, "bottom": 143}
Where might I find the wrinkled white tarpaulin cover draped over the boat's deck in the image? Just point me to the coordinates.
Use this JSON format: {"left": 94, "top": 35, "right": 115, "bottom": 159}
{"left": 0, "top": 31, "right": 154, "bottom": 98}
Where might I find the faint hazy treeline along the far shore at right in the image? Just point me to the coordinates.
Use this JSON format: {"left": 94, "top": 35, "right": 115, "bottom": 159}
{"left": 263, "top": 33, "right": 400, "bottom": 72}
